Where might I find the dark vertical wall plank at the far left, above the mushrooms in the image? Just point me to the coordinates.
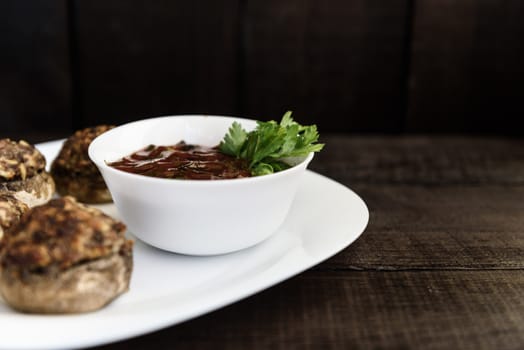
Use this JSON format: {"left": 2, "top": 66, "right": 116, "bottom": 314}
{"left": 0, "top": 0, "right": 72, "bottom": 138}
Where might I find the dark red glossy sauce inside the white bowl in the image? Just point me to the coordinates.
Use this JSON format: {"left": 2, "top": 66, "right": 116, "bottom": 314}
{"left": 108, "top": 141, "right": 251, "bottom": 180}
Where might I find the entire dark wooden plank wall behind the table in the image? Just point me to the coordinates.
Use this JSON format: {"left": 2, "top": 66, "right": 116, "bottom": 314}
{"left": 0, "top": 0, "right": 524, "bottom": 138}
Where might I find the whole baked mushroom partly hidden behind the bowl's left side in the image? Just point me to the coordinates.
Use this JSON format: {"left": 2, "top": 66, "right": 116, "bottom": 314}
{"left": 51, "top": 125, "right": 114, "bottom": 203}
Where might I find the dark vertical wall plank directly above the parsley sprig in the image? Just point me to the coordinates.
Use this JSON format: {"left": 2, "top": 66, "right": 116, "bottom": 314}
{"left": 242, "top": 0, "right": 407, "bottom": 132}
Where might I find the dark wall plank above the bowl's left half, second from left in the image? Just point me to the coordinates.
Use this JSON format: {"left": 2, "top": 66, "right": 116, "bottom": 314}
{"left": 76, "top": 0, "right": 242, "bottom": 125}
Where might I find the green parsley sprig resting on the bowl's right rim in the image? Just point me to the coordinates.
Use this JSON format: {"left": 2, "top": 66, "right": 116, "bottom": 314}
{"left": 218, "top": 111, "right": 324, "bottom": 176}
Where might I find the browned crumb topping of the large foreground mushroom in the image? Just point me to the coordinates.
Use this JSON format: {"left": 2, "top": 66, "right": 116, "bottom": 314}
{"left": 0, "top": 197, "right": 133, "bottom": 271}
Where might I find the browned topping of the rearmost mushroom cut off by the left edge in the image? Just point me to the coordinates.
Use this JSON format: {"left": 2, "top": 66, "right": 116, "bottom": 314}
{"left": 0, "top": 139, "right": 46, "bottom": 181}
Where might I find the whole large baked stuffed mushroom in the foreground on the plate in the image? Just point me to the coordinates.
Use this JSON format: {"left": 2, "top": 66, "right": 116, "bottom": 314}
{"left": 0, "top": 197, "right": 133, "bottom": 313}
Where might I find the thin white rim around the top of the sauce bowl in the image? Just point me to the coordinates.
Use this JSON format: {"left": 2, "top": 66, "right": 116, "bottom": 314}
{"left": 88, "top": 114, "right": 314, "bottom": 186}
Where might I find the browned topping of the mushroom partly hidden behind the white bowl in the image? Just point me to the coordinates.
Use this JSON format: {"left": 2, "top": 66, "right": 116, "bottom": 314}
{"left": 51, "top": 125, "right": 114, "bottom": 176}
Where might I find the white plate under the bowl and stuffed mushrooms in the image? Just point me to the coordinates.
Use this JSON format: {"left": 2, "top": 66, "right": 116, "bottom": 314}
{"left": 0, "top": 141, "right": 369, "bottom": 349}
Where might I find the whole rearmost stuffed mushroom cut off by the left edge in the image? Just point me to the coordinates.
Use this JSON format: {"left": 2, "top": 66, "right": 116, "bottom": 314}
{"left": 0, "top": 139, "right": 55, "bottom": 207}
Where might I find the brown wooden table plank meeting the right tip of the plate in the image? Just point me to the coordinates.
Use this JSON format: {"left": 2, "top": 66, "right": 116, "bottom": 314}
{"left": 319, "top": 186, "right": 524, "bottom": 270}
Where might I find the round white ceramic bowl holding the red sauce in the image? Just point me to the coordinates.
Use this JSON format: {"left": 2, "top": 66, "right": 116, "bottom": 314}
{"left": 89, "top": 115, "right": 313, "bottom": 255}
